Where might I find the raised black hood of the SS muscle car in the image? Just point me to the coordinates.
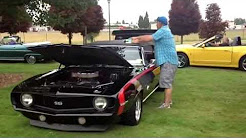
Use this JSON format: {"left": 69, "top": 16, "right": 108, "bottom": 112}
{"left": 28, "top": 44, "right": 132, "bottom": 67}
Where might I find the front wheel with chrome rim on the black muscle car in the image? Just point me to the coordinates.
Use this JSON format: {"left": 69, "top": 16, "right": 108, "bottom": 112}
{"left": 121, "top": 95, "right": 142, "bottom": 126}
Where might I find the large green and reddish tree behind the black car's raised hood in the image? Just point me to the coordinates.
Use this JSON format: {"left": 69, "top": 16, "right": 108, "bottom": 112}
{"left": 47, "top": 0, "right": 97, "bottom": 44}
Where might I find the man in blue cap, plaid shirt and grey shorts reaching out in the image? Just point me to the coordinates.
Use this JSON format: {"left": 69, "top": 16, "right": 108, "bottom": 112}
{"left": 132, "top": 17, "right": 178, "bottom": 108}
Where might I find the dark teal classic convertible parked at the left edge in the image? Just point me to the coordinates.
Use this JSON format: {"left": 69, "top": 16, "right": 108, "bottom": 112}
{"left": 0, "top": 36, "right": 50, "bottom": 64}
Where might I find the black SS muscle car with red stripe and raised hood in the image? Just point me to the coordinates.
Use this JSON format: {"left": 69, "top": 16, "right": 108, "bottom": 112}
{"left": 11, "top": 41, "right": 160, "bottom": 131}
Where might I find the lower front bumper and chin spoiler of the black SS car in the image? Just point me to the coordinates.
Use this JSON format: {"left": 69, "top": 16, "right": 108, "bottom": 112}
{"left": 14, "top": 106, "right": 116, "bottom": 132}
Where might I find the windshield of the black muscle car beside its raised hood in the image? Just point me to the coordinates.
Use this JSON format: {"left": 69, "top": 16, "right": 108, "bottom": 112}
{"left": 109, "top": 47, "right": 143, "bottom": 65}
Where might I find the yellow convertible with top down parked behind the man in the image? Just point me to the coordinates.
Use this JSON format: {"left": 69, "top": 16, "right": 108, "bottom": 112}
{"left": 176, "top": 35, "right": 246, "bottom": 71}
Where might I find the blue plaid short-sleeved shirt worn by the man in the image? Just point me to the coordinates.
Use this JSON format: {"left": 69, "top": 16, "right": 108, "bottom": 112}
{"left": 152, "top": 26, "right": 178, "bottom": 66}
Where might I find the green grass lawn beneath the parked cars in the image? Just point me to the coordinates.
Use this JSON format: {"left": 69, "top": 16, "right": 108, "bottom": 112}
{"left": 0, "top": 63, "right": 246, "bottom": 137}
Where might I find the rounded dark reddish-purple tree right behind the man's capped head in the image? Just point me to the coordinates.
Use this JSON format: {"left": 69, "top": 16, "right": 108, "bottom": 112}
{"left": 169, "top": 0, "right": 201, "bottom": 44}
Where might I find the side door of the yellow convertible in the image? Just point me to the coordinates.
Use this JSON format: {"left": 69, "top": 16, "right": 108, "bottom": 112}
{"left": 192, "top": 46, "right": 232, "bottom": 66}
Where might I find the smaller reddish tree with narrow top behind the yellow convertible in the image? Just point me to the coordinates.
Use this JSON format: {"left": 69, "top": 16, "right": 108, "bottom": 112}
{"left": 199, "top": 3, "right": 228, "bottom": 38}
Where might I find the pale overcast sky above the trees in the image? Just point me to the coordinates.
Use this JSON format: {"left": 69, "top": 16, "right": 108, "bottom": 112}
{"left": 98, "top": 0, "right": 246, "bottom": 24}
